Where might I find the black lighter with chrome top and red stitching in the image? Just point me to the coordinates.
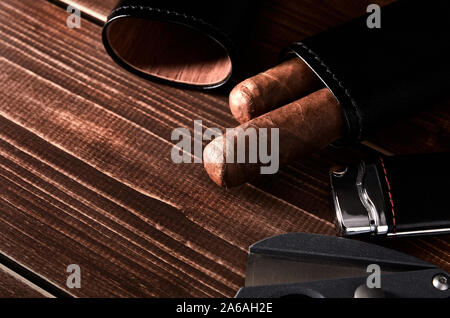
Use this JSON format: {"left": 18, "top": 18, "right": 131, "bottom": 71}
{"left": 331, "top": 153, "right": 450, "bottom": 237}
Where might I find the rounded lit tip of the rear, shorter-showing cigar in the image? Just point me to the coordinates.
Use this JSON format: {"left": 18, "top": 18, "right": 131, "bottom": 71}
{"left": 229, "top": 80, "right": 255, "bottom": 124}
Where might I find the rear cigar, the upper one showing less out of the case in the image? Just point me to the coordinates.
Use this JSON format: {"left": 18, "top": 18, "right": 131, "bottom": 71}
{"left": 229, "top": 58, "right": 323, "bottom": 124}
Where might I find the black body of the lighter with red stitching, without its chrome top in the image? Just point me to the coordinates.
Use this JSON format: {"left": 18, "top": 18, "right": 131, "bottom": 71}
{"left": 377, "top": 153, "right": 450, "bottom": 234}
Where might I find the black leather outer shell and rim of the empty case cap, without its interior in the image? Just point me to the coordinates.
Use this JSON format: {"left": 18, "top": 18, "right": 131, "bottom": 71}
{"left": 103, "top": 0, "right": 252, "bottom": 89}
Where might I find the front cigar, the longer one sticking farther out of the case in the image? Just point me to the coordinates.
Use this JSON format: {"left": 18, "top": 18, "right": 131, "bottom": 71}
{"left": 203, "top": 88, "right": 345, "bottom": 187}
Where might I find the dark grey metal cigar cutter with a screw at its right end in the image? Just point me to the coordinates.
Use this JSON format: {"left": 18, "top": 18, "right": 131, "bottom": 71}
{"left": 236, "top": 233, "right": 450, "bottom": 298}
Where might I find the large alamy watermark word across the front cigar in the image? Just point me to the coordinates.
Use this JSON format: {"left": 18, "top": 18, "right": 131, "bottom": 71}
{"left": 171, "top": 120, "right": 280, "bottom": 174}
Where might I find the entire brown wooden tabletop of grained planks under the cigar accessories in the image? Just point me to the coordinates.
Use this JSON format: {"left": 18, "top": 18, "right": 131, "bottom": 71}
{"left": 0, "top": 0, "right": 450, "bottom": 297}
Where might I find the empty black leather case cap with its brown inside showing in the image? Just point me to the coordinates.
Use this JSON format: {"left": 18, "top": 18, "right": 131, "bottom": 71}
{"left": 103, "top": 0, "right": 251, "bottom": 88}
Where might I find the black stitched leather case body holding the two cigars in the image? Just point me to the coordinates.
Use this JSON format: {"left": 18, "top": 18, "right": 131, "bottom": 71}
{"left": 282, "top": 0, "right": 450, "bottom": 143}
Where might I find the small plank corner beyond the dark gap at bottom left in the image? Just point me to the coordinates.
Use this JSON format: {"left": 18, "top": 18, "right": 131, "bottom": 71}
{"left": 0, "top": 264, "right": 52, "bottom": 298}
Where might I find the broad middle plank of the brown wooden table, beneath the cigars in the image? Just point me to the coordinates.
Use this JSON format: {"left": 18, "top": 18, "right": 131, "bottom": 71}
{"left": 0, "top": 1, "right": 333, "bottom": 296}
